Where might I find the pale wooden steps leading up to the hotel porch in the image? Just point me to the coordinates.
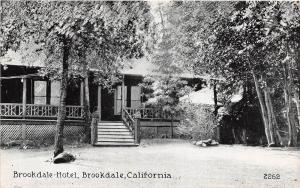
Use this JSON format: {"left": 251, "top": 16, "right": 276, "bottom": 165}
{"left": 95, "top": 121, "right": 138, "bottom": 146}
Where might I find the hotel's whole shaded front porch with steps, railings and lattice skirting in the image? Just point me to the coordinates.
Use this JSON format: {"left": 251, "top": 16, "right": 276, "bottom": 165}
{"left": 0, "top": 66, "right": 177, "bottom": 145}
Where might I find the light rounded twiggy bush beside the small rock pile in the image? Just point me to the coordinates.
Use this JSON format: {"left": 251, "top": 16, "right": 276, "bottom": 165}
{"left": 178, "top": 103, "right": 217, "bottom": 140}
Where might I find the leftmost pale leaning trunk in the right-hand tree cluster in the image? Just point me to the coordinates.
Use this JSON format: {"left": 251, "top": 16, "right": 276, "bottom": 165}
{"left": 251, "top": 70, "right": 271, "bottom": 144}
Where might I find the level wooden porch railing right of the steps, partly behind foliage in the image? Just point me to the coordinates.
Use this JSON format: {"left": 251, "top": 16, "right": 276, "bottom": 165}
{"left": 126, "top": 108, "right": 181, "bottom": 120}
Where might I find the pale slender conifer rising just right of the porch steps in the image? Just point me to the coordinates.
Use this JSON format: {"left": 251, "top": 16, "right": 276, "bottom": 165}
{"left": 139, "top": 2, "right": 192, "bottom": 116}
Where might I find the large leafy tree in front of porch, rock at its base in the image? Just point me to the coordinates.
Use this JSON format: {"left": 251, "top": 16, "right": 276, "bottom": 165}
{"left": 1, "top": 1, "right": 150, "bottom": 156}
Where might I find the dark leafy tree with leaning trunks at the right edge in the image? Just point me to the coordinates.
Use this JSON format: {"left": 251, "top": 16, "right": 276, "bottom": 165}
{"left": 214, "top": 2, "right": 299, "bottom": 146}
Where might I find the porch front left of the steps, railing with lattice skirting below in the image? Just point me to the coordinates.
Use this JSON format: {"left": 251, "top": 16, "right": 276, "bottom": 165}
{"left": 0, "top": 103, "right": 86, "bottom": 144}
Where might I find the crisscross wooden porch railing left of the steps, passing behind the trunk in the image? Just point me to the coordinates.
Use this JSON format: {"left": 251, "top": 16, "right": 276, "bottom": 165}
{"left": 0, "top": 103, "right": 84, "bottom": 119}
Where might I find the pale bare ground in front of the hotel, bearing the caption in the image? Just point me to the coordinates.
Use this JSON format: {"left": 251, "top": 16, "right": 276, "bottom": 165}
{"left": 0, "top": 140, "right": 300, "bottom": 188}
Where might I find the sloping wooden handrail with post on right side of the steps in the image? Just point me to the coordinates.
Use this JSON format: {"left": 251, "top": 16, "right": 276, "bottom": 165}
{"left": 122, "top": 108, "right": 140, "bottom": 144}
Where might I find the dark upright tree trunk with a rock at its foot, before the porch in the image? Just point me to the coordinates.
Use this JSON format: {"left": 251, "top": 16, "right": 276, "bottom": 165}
{"left": 54, "top": 38, "right": 70, "bottom": 157}
